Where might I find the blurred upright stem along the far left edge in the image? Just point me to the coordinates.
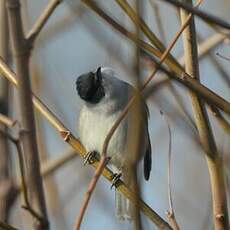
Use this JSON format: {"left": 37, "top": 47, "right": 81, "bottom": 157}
{"left": 0, "top": 0, "right": 17, "bottom": 222}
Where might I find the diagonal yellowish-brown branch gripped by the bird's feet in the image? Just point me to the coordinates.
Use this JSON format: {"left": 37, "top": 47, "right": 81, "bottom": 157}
{"left": 0, "top": 53, "right": 171, "bottom": 229}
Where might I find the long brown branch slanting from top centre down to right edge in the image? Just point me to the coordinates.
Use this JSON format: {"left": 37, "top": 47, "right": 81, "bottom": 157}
{"left": 82, "top": 0, "right": 230, "bottom": 114}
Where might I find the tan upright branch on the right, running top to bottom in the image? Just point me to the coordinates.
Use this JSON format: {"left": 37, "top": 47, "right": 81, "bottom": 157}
{"left": 181, "top": 0, "right": 229, "bottom": 230}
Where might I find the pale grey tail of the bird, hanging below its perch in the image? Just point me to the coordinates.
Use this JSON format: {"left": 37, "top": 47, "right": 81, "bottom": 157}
{"left": 115, "top": 190, "right": 134, "bottom": 221}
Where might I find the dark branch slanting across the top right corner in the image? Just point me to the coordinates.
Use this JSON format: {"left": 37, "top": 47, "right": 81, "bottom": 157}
{"left": 159, "top": 0, "right": 230, "bottom": 30}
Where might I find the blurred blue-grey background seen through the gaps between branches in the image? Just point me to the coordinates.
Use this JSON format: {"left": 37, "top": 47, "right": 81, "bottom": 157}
{"left": 0, "top": 0, "right": 230, "bottom": 230}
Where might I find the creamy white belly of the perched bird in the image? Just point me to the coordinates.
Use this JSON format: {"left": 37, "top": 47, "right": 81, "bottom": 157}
{"left": 79, "top": 109, "right": 127, "bottom": 168}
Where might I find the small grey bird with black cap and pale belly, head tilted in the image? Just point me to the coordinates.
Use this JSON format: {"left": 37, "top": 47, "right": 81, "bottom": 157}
{"left": 76, "top": 67, "right": 152, "bottom": 220}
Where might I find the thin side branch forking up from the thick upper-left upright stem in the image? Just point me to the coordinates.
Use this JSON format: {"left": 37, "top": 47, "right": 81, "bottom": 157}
{"left": 26, "top": 0, "right": 62, "bottom": 44}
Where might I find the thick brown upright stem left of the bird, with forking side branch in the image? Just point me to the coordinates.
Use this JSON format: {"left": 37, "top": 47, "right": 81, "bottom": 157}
{"left": 7, "top": 0, "right": 49, "bottom": 229}
